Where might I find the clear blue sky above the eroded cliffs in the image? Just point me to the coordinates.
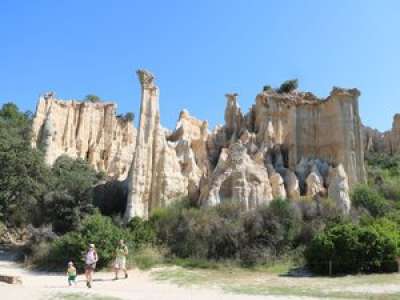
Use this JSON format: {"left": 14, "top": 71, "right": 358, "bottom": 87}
{"left": 0, "top": 0, "right": 400, "bottom": 130}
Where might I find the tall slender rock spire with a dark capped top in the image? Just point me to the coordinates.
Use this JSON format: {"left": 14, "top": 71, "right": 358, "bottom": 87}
{"left": 124, "top": 70, "right": 160, "bottom": 222}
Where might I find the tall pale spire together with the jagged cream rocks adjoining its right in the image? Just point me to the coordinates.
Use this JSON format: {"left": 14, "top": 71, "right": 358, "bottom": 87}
{"left": 124, "top": 70, "right": 208, "bottom": 221}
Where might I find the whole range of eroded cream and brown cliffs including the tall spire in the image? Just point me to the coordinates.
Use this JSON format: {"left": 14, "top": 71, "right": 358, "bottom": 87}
{"left": 34, "top": 70, "right": 368, "bottom": 222}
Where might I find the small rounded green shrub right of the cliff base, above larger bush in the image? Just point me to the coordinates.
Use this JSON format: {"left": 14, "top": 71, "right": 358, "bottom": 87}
{"left": 351, "top": 185, "right": 389, "bottom": 217}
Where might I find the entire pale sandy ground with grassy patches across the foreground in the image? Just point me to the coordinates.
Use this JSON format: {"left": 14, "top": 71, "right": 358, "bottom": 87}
{"left": 0, "top": 250, "right": 400, "bottom": 300}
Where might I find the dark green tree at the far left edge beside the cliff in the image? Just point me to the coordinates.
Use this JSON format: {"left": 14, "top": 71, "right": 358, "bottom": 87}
{"left": 0, "top": 103, "right": 49, "bottom": 226}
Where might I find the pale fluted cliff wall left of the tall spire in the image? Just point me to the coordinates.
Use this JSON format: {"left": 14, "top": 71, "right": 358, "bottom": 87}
{"left": 32, "top": 93, "right": 136, "bottom": 179}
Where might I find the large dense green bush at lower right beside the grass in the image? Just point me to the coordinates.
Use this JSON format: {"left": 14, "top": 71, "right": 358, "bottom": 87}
{"left": 305, "top": 221, "right": 398, "bottom": 274}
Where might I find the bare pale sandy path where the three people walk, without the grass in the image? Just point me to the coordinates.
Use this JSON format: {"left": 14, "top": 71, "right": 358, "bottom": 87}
{"left": 0, "top": 250, "right": 315, "bottom": 300}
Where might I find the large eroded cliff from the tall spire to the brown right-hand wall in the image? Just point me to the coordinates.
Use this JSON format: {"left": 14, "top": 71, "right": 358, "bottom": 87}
{"left": 125, "top": 70, "right": 366, "bottom": 221}
